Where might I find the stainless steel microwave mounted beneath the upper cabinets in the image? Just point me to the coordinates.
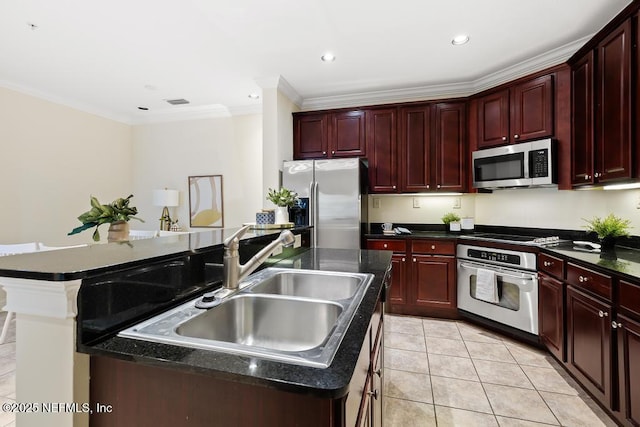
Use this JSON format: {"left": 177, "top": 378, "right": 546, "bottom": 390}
{"left": 471, "top": 138, "right": 557, "bottom": 189}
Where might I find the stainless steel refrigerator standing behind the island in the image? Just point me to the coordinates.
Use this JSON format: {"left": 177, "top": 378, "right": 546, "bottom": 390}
{"left": 282, "top": 158, "right": 367, "bottom": 249}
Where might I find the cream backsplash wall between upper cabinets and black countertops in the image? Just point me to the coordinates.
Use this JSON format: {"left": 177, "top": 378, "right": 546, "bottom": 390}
{"left": 368, "top": 188, "right": 640, "bottom": 235}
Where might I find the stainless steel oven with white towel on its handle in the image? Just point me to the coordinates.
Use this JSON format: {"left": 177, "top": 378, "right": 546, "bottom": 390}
{"left": 456, "top": 244, "right": 538, "bottom": 335}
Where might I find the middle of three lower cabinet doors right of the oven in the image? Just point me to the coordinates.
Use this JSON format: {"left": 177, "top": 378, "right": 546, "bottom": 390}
{"left": 567, "top": 286, "right": 613, "bottom": 406}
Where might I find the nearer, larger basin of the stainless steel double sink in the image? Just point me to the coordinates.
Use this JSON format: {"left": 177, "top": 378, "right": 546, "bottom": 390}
{"left": 176, "top": 295, "right": 343, "bottom": 351}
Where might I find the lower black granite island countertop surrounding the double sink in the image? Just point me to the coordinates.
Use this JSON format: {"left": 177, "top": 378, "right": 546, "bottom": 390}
{"left": 78, "top": 249, "right": 391, "bottom": 398}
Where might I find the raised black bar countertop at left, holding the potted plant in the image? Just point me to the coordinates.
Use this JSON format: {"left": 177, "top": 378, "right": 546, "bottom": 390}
{"left": 0, "top": 227, "right": 308, "bottom": 281}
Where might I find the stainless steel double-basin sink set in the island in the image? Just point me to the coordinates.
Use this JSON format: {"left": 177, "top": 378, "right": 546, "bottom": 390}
{"left": 119, "top": 268, "right": 373, "bottom": 368}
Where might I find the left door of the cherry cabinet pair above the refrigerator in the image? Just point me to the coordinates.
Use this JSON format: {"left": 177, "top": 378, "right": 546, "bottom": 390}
{"left": 293, "top": 114, "right": 329, "bottom": 160}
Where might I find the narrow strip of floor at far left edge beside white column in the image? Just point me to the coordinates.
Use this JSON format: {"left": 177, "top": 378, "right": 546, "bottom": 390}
{"left": 0, "top": 311, "right": 16, "bottom": 427}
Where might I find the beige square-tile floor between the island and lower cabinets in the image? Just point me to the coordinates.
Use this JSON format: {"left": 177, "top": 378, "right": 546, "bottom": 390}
{"left": 384, "top": 315, "right": 616, "bottom": 427}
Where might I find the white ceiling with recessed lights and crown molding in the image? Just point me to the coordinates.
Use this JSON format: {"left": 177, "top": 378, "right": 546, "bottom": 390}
{"left": 0, "top": 0, "right": 630, "bottom": 123}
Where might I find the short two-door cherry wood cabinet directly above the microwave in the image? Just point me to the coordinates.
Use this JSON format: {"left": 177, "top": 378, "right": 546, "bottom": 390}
{"left": 478, "top": 74, "right": 554, "bottom": 148}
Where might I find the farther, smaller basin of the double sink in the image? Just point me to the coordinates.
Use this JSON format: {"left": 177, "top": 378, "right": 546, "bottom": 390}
{"left": 246, "top": 268, "right": 366, "bottom": 301}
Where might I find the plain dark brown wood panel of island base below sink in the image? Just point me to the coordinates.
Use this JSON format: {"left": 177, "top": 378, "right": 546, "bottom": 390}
{"left": 90, "top": 356, "right": 346, "bottom": 427}
